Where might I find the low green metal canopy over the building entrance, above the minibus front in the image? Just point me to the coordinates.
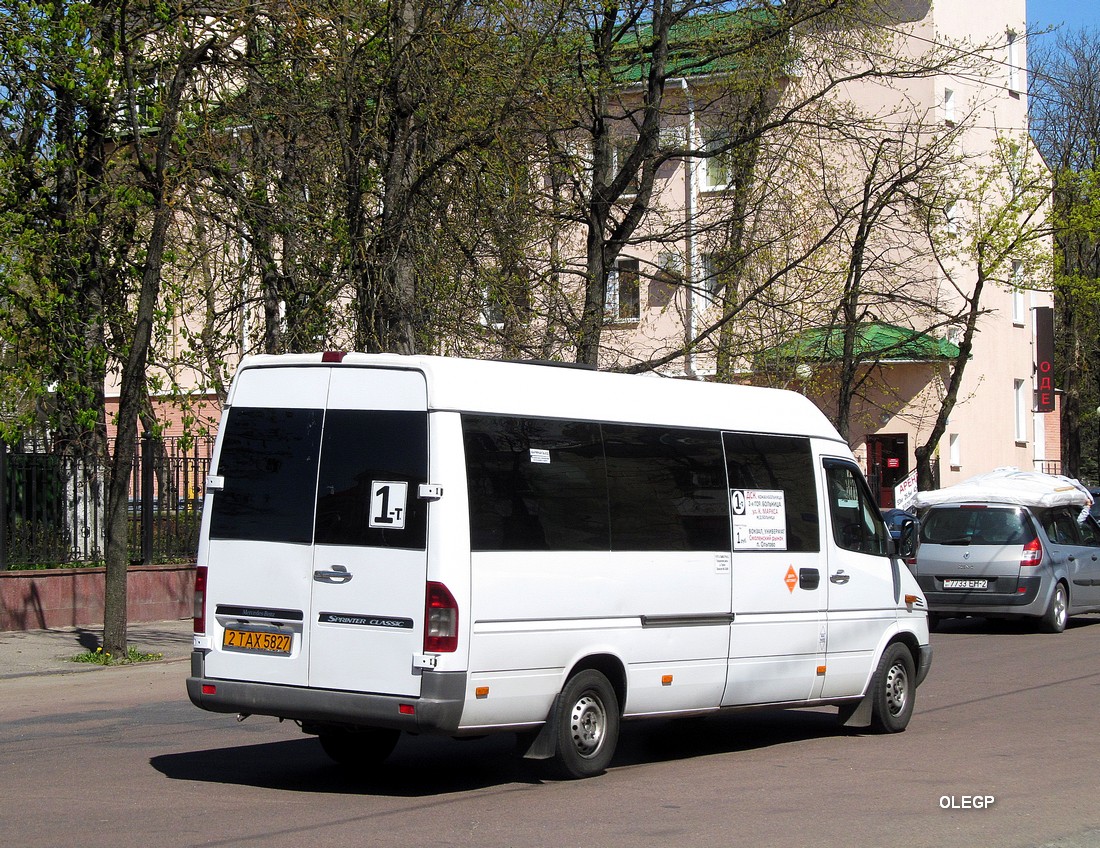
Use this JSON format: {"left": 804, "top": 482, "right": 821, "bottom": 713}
{"left": 760, "top": 321, "right": 959, "bottom": 362}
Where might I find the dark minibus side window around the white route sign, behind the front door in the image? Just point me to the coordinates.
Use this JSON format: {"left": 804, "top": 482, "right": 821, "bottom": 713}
{"left": 724, "top": 433, "right": 821, "bottom": 552}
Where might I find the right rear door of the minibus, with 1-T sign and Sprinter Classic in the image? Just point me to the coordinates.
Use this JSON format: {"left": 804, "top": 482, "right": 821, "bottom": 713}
{"left": 309, "top": 367, "right": 428, "bottom": 695}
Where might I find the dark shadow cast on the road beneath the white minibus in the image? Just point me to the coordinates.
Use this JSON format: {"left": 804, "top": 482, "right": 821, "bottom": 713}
{"left": 150, "top": 709, "right": 858, "bottom": 797}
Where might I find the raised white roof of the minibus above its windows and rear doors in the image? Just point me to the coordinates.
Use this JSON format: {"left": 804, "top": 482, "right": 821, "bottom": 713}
{"left": 236, "top": 353, "right": 844, "bottom": 442}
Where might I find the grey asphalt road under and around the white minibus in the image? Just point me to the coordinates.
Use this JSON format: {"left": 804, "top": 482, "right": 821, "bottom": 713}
{"left": 0, "top": 616, "right": 1100, "bottom": 848}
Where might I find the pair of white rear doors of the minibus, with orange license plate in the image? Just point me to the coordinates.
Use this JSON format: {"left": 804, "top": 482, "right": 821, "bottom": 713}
{"left": 206, "top": 366, "right": 428, "bottom": 695}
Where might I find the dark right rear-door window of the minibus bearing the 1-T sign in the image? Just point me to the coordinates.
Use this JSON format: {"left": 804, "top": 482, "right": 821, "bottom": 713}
{"left": 316, "top": 409, "right": 428, "bottom": 550}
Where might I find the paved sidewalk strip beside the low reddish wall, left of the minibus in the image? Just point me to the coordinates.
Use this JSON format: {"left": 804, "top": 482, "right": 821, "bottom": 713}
{"left": 0, "top": 618, "right": 193, "bottom": 680}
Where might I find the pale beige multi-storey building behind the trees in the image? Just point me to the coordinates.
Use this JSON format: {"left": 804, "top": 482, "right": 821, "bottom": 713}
{"left": 111, "top": 0, "right": 1059, "bottom": 506}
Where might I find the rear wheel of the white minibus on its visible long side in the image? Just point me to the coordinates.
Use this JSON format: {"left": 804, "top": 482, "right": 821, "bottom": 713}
{"left": 550, "top": 669, "right": 619, "bottom": 780}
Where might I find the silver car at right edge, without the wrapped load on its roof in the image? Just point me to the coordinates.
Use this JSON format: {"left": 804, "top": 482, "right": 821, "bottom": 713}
{"left": 909, "top": 503, "right": 1100, "bottom": 632}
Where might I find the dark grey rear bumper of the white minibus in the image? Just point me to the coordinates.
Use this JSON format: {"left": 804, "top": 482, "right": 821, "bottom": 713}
{"left": 187, "top": 650, "right": 466, "bottom": 735}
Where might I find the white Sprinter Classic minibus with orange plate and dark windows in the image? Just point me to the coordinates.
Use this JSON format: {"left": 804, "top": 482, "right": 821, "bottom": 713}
{"left": 187, "top": 352, "right": 932, "bottom": 778}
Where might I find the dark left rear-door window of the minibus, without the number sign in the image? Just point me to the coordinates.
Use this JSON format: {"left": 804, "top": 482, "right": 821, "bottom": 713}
{"left": 210, "top": 407, "right": 325, "bottom": 544}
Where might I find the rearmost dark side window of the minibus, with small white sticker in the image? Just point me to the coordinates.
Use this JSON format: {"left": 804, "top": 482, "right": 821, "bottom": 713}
{"left": 462, "top": 415, "right": 609, "bottom": 551}
